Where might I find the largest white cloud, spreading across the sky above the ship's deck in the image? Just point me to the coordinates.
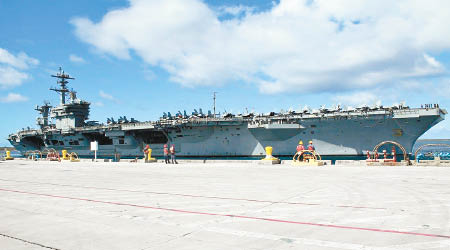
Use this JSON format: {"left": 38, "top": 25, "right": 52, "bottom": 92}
{"left": 71, "top": 0, "right": 450, "bottom": 93}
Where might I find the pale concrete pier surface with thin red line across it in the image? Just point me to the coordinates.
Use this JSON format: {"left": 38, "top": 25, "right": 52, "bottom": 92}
{"left": 0, "top": 160, "right": 450, "bottom": 250}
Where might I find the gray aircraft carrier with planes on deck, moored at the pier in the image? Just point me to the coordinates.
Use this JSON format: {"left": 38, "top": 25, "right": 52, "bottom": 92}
{"left": 8, "top": 69, "right": 447, "bottom": 158}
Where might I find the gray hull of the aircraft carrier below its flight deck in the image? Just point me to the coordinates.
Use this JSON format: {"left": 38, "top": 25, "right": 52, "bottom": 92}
{"left": 11, "top": 109, "right": 443, "bottom": 157}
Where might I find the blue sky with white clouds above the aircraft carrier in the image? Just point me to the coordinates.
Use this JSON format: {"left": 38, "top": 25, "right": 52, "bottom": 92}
{"left": 0, "top": 0, "right": 450, "bottom": 146}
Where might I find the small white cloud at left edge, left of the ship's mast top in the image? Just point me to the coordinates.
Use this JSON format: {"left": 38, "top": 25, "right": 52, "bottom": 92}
{"left": 0, "top": 48, "right": 39, "bottom": 88}
